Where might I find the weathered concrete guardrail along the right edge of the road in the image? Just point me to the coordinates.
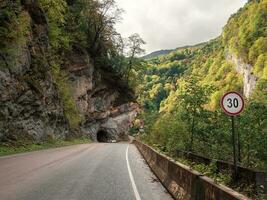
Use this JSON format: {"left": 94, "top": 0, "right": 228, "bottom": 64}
{"left": 133, "top": 140, "right": 249, "bottom": 200}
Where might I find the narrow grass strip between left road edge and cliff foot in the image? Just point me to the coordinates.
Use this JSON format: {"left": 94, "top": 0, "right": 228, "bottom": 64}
{"left": 0, "top": 137, "right": 91, "bottom": 157}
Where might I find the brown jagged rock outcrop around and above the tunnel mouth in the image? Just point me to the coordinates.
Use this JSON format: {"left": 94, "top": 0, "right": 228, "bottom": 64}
{"left": 69, "top": 48, "right": 138, "bottom": 142}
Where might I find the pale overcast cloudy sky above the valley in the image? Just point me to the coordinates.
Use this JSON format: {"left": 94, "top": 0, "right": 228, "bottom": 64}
{"left": 116, "top": 0, "right": 247, "bottom": 53}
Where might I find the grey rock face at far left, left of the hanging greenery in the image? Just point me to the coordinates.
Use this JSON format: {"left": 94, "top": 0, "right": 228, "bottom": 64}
{"left": 0, "top": 0, "right": 68, "bottom": 141}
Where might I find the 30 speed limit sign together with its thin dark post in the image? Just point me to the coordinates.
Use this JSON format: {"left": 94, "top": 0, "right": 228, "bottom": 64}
{"left": 221, "top": 92, "right": 245, "bottom": 180}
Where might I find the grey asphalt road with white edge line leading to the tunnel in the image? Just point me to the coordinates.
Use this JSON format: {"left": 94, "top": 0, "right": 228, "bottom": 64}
{"left": 0, "top": 143, "right": 172, "bottom": 200}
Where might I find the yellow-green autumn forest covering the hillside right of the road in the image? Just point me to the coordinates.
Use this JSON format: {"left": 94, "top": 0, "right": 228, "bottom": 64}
{"left": 133, "top": 0, "right": 267, "bottom": 184}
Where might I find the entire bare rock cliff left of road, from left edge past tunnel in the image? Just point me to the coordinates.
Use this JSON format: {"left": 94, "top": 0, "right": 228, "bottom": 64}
{"left": 0, "top": 0, "right": 137, "bottom": 142}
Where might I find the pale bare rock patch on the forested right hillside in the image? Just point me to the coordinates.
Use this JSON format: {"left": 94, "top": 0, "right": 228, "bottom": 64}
{"left": 227, "top": 53, "right": 258, "bottom": 98}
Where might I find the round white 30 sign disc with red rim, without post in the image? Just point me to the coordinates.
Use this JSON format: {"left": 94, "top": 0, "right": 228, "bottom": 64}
{"left": 221, "top": 92, "right": 244, "bottom": 116}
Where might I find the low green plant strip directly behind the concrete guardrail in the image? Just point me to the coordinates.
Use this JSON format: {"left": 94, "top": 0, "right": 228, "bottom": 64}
{"left": 152, "top": 145, "right": 267, "bottom": 200}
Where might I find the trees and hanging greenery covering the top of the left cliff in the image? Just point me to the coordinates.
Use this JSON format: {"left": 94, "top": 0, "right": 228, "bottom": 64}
{"left": 0, "top": 0, "right": 144, "bottom": 133}
